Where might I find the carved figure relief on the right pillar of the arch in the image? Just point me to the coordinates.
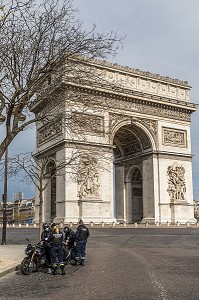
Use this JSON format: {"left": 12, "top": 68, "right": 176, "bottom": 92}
{"left": 167, "top": 163, "right": 186, "bottom": 202}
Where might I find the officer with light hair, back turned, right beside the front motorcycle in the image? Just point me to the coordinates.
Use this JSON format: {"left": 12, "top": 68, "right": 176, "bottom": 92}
{"left": 47, "top": 223, "right": 66, "bottom": 275}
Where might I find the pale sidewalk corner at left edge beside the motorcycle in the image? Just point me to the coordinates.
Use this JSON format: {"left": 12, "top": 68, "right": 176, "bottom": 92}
{"left": 0, "top": 244, "right": 26, "bottom": 277}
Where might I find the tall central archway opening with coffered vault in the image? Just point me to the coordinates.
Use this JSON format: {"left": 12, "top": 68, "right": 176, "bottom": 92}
{"left": 113, "top": 124, "right": 154, "bottom": 223}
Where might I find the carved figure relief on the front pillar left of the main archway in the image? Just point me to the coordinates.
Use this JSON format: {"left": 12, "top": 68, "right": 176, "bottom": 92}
{"left": 77, "top": 156, "right": 100, "bottom": 199}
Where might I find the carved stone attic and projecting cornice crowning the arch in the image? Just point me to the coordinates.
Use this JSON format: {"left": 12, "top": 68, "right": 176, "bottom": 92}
{"left": 31, "top": 58, "right": 198, "bottom": 113}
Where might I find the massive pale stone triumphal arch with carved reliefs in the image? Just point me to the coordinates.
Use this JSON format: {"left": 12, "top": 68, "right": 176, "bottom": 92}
{"left": 32, "top": 57, "right": 197, "bottom": 223}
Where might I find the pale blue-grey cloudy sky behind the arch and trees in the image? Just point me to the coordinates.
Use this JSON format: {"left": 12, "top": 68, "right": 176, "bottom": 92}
{"left": 0, "top": 0, "right": 199, "bottom": 200}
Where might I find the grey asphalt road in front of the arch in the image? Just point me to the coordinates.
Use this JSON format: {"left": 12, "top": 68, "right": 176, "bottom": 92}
{"left": 0, "top": 228, "right": 199, "bottom": 300}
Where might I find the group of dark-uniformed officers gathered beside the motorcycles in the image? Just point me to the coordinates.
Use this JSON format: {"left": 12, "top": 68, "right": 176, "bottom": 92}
{"left": 41, "top": 220, "right": 90, "bottom": 275}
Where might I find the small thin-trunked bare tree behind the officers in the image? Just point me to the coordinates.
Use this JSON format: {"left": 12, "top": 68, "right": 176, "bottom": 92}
{"left": 0, "top": 149, "right": 109, "bottom": 235}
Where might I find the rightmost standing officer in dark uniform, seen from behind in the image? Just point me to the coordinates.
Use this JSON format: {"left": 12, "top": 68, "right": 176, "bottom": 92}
{"left": 76, "top": 220, "right": 90, "bottom": 266}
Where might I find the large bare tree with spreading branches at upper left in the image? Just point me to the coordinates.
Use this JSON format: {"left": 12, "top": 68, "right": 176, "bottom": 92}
{"left": 0, "top": 0, "right": 122, "bottom": 159}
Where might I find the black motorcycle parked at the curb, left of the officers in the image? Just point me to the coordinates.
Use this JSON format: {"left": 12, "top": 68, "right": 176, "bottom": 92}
{"left": 20, "top": 239, "right": 47, "bottom": 275}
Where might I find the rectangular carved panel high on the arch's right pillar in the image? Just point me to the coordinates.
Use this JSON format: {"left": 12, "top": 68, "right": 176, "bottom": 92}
{"left": 163, "top": 128, "right": 187, "bottom": 147}
